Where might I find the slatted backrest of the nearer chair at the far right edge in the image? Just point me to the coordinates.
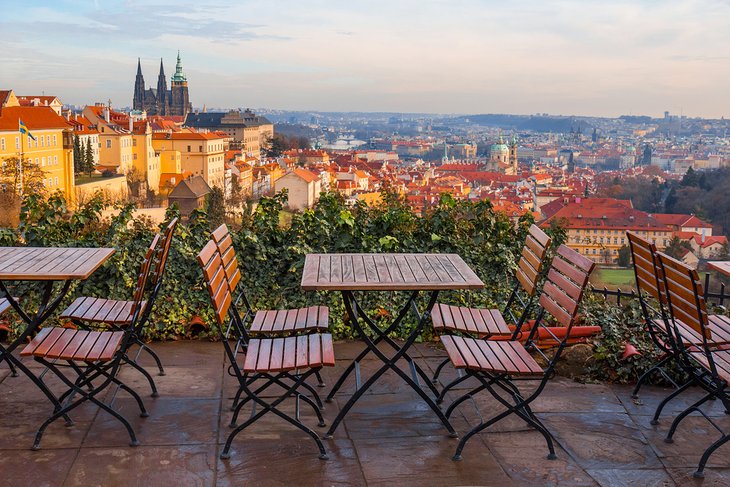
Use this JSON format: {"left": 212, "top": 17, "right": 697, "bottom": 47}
{"left": 657, "top": 252, "right": 710, "bottom": 338}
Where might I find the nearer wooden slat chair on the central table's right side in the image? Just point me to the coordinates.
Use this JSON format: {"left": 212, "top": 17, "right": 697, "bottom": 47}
{"left": 441, "top": 245, "right": 595, "bottom": 460}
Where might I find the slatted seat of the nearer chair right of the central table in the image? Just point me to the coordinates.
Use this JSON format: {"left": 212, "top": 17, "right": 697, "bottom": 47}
{"left": 440, "top": 335, "right": 544, "bottom": 375}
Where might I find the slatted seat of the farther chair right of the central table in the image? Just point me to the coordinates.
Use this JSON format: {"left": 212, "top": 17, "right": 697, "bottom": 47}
{"left": 431, "top": 303, "right": 513, "bottom": 337}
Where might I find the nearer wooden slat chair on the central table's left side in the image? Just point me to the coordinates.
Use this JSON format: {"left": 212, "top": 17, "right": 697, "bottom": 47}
{"left": 197, "top": 240, "right": 335, "bottom": 459}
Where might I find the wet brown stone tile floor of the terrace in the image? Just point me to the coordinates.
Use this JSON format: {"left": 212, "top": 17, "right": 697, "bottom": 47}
{"left": 0, "top": 342, "right": 730, "bottom": 487}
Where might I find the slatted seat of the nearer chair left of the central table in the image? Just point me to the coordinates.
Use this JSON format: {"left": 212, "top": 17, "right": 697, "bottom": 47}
{"left": 243, "top": 333, "right": 335, "bottom": 373}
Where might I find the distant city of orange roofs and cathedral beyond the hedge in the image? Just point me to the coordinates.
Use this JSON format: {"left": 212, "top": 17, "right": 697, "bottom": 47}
{"left": 0, "top": 53, "right": 730, "bottom": 265}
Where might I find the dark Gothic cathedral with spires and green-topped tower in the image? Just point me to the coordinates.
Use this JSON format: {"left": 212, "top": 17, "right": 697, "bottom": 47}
{"left": 132, "top": 51, "right": 192, "bottom": 117}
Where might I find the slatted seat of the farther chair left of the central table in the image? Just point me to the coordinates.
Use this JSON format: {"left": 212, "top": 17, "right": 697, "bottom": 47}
{"left": 249, "top": 306, "right": 329, "bottom": 334}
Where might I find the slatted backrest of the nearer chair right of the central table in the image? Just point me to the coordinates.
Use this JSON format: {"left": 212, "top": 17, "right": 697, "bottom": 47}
{"left": 539, "top": 245, "right": 595, "bottom": 332}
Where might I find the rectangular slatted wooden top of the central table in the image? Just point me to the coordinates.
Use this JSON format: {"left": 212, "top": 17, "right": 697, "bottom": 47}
{"left": 302, "top": 254, "right": 484, "bottom": 291}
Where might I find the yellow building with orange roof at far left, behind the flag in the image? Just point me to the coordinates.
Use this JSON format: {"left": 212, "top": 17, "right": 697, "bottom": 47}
{"left": 0, "top": 90, "right": 75, "bottom": 202}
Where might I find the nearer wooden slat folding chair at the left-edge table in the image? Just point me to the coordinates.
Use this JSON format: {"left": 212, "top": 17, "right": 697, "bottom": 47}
{"left": 20, "top": 235, "right": 160, "bottom": 450}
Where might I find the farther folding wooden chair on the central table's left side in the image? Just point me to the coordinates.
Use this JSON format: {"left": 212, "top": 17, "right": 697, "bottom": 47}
{"left": 206, "top": 227, "right": 329, "bottom": 410}
